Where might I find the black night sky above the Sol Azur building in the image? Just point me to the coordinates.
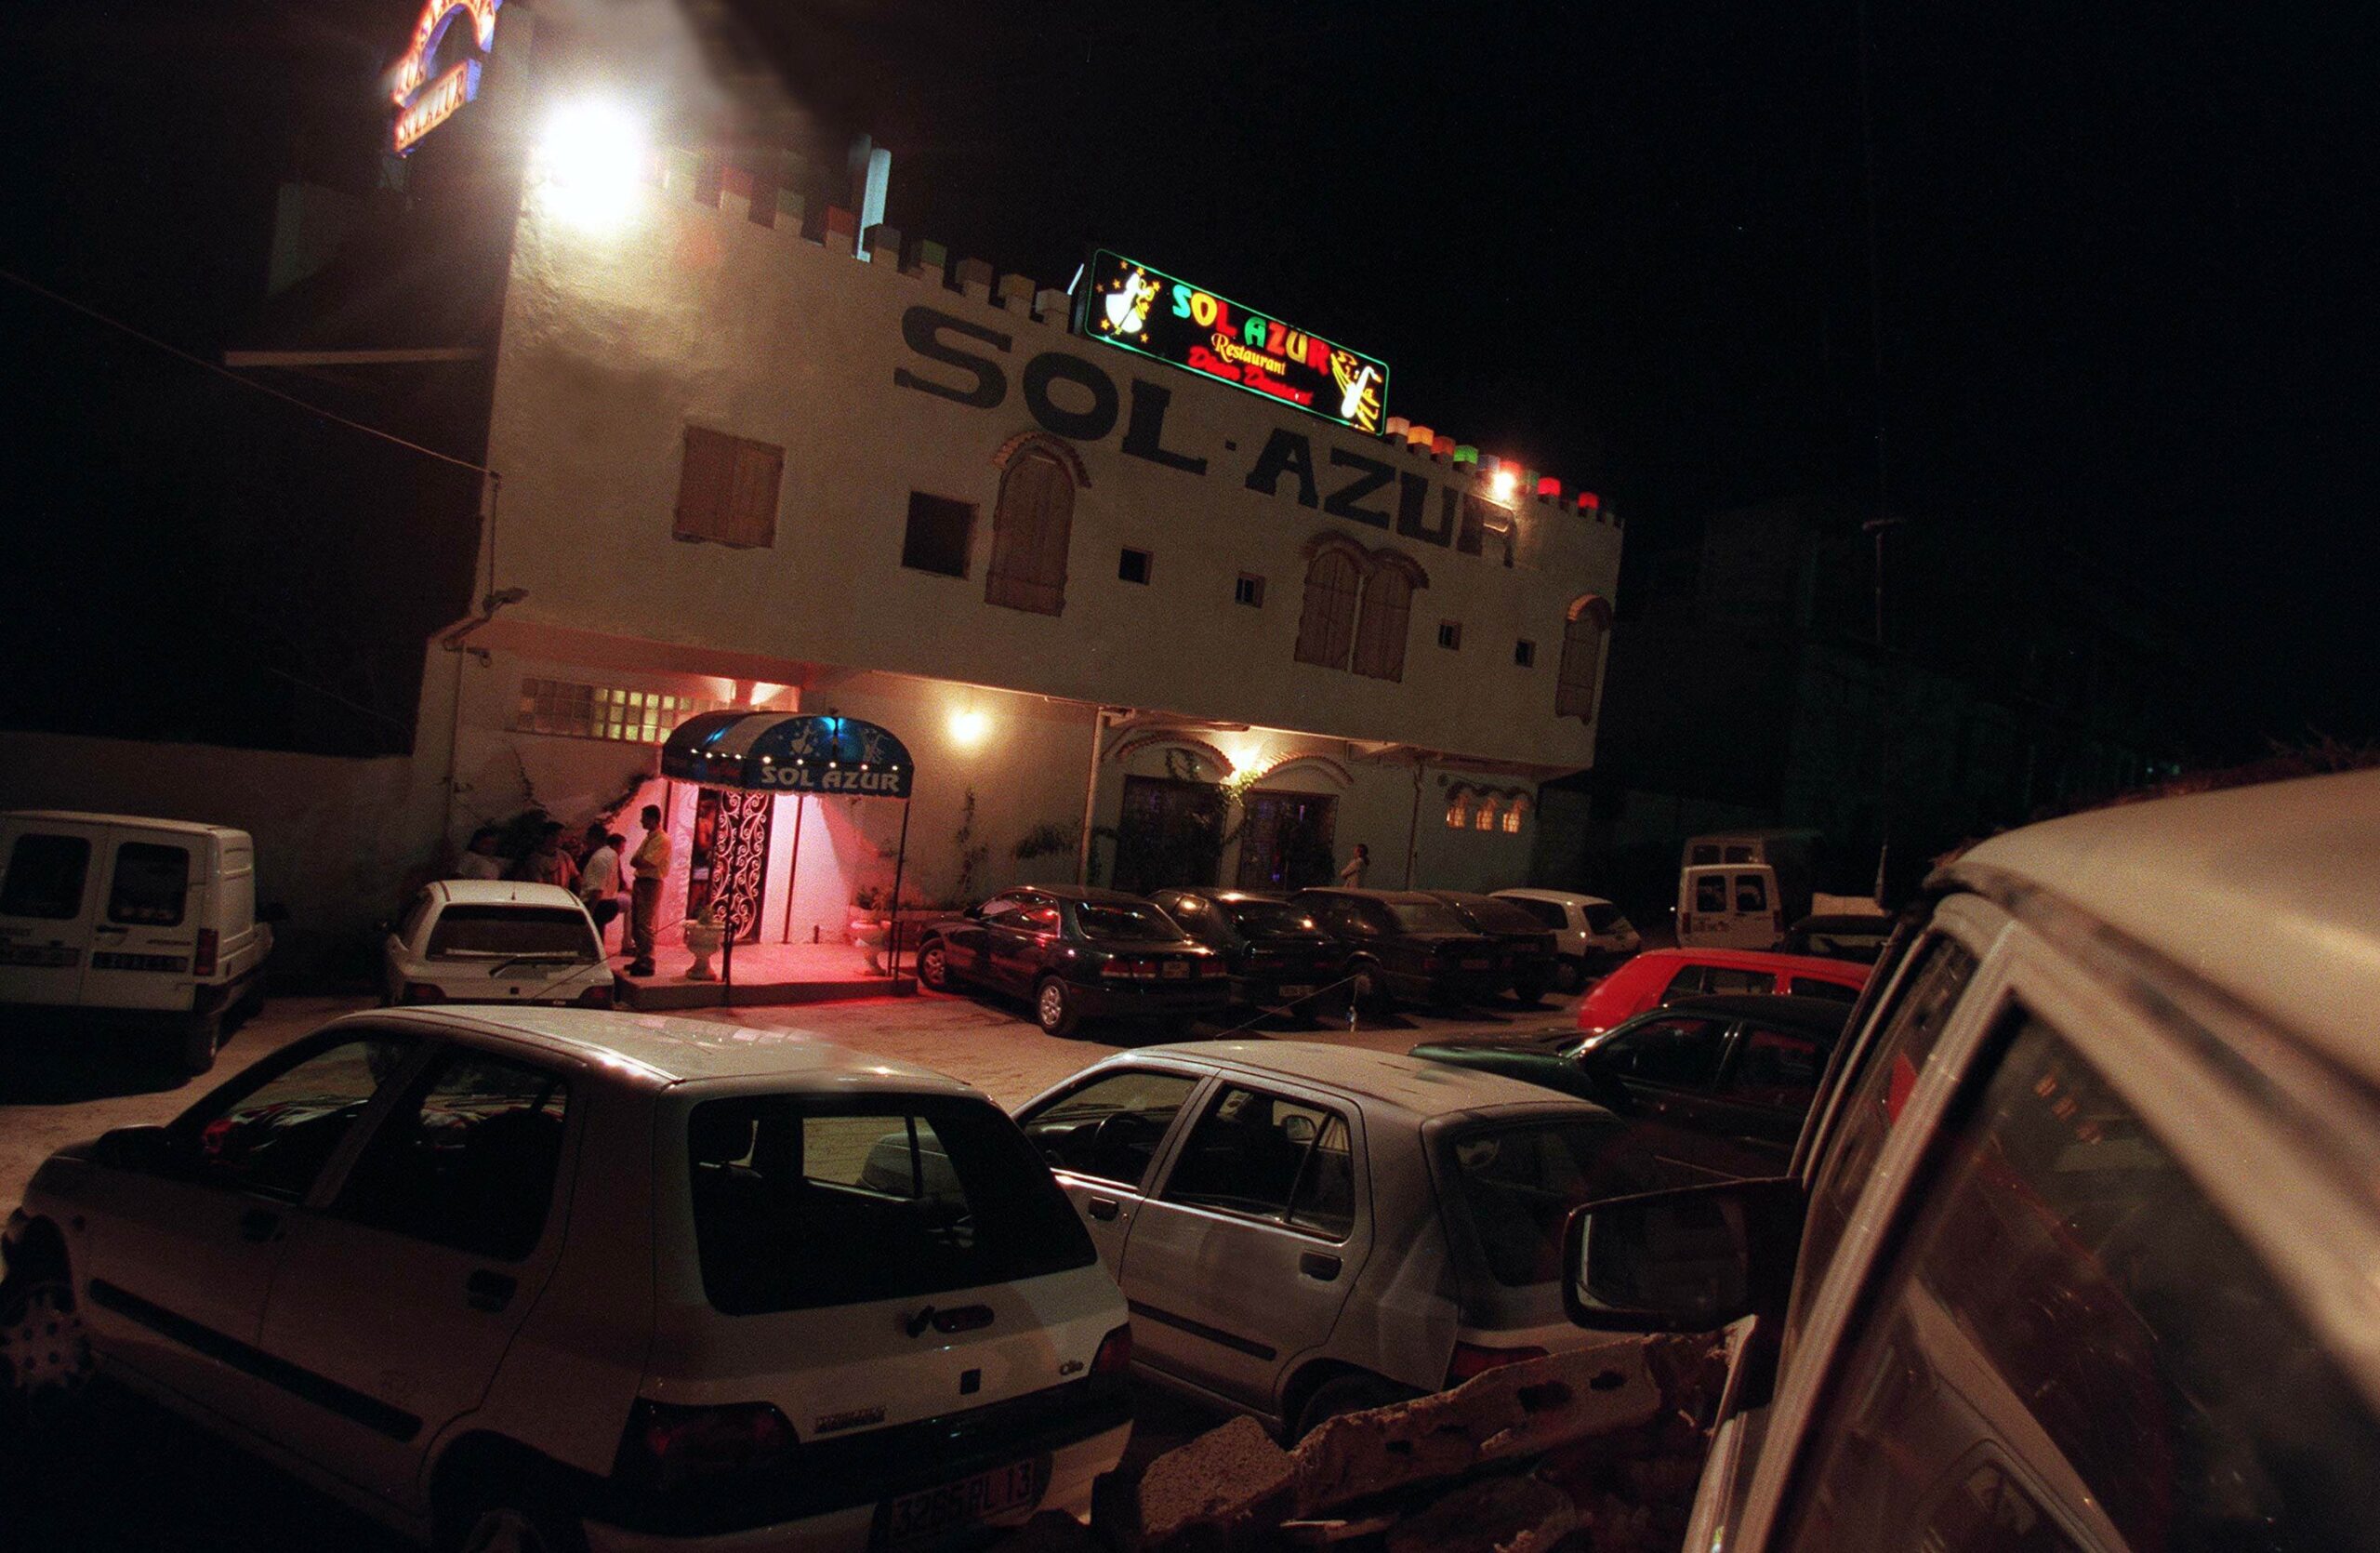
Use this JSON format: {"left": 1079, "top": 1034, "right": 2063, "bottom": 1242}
{"left": 0, "top": 0, "right": 2380, "bottom": 752}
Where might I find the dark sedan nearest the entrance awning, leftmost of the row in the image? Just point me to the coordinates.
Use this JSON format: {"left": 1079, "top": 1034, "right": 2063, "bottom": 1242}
{"left": 917, "top": 883, "right": 1231, "bottom": 1036}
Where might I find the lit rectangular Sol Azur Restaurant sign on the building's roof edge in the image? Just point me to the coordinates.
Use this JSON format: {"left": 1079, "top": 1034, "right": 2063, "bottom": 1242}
{"left": 1074, "top": 247, "right": 1387, "bottom": 433}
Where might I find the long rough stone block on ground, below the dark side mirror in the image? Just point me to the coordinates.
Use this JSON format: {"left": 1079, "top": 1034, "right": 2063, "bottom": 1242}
{"left": 1295, "top": 1336, "right": 1712, "bottom": 1518}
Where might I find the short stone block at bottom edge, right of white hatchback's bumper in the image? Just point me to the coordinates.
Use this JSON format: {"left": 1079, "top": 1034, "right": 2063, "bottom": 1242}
{"left": 1092, "top": 1417, "right": 1292, "bottom": 1553}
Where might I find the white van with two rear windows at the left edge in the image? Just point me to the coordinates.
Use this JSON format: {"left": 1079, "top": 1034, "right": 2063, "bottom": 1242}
{"left": 0, "top": 810, "right": 273, "bottom": 1074}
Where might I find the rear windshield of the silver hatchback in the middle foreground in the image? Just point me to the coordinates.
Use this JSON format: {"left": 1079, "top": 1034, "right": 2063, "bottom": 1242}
{"left": 1440, "top": 1115, "right": 1654, "bottom": 1289}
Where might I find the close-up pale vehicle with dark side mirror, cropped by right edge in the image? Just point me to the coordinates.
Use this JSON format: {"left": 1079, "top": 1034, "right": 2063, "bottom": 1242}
{"left": 1566, "top": 772, "right": 2380, "bottom": 1553}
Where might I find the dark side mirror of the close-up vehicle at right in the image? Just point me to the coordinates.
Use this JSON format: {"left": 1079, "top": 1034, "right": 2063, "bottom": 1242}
{"left": 1561, "top": 1176, "right": 1802, "bottom": 1332}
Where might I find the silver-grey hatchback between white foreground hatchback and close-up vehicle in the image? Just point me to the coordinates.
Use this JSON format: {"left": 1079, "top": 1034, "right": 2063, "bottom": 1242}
{"left": 1019, "top": 1041, "right": 1685, "bottom": 1439}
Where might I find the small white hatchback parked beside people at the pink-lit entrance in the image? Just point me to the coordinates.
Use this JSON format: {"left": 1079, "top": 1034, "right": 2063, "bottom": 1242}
{"left": 381, "top": 879, "right": 612, "bottom": 1007}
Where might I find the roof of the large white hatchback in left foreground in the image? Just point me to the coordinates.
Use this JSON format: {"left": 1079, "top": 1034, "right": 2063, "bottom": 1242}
{"left": 321, "top": 1002, "right": 978, "bottom": 1095}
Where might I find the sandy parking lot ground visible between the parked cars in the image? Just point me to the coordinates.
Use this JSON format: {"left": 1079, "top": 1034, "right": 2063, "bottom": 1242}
{"left": 0, "top": 993, "right": 1573, "bottom": 1553}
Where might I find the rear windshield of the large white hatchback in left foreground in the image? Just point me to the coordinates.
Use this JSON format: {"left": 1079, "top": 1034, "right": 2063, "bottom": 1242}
{"left": 685, "top": 1095, "right": 1097, "bottom": 1315}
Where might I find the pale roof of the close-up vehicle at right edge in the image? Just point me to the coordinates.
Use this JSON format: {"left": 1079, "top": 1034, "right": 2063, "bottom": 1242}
{"left": 1939, "top": 769, "right": 2380, "bottom": 1082}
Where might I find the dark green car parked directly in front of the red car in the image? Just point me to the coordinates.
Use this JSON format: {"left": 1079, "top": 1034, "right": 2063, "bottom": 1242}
{"left": 1414, "top": 996, "right": 1852, "bottom": 1179}
